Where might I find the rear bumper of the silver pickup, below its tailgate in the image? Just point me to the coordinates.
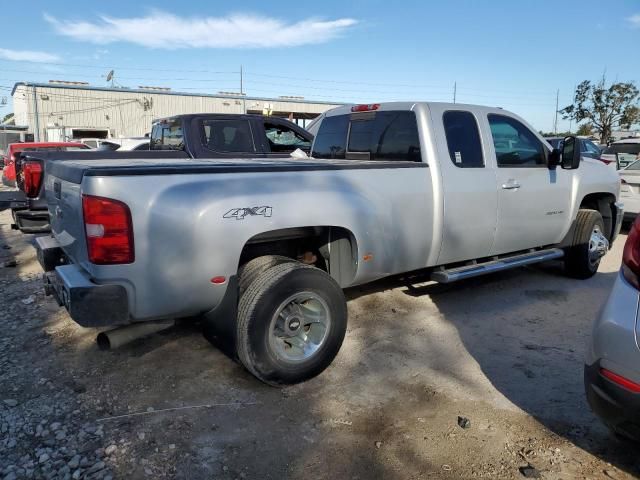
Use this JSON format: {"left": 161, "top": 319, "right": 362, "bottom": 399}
{"left": 36, "top": 237, "right": 130, "bottom": 327}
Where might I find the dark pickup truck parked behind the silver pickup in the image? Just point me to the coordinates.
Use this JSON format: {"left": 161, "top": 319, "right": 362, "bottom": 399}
{"left": 13, "top": 114, "right": 313, "bottom": 233}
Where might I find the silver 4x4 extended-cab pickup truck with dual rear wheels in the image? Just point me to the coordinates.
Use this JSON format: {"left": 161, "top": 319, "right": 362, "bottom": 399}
{"left": 37, "top": 103, "right": 623, "bottom": 385}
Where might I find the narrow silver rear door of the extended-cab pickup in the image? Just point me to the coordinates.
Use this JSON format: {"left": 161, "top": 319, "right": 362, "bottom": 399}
{"left": 430, "top": 104, "right": 498, "bottom": 264}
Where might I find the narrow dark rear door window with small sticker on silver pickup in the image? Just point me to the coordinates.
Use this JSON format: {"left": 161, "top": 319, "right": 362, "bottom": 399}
{"left": 442, "top": 111, "right": 484, "bottom": 168}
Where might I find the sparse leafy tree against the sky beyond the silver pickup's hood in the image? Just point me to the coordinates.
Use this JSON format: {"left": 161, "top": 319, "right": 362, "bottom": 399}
{"left": 560, "top": 77, "right": 640, "bottom": 143}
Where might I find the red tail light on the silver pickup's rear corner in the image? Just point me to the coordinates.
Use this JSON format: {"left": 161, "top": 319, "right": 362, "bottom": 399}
{"left": 82, "top": 195, "right": 135, "bottom": 265}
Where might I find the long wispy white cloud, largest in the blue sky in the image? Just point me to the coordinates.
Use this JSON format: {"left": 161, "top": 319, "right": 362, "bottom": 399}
{"left": 44, "top": 10, "right": 357, "bottom": 49}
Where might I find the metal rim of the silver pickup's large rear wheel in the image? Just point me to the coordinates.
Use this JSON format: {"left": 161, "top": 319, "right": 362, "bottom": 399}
{"left": 269, "top": 292, "right": 331, "bottom": 363}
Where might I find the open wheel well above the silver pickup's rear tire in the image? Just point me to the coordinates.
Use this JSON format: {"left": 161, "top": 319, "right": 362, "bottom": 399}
{"left": 238, "top": 226, "right": 358, "bottom": 286}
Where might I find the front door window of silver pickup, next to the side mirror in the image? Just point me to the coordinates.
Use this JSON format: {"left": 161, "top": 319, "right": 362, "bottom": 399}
{"left": 488, "top": 114, "right": 546, "bottom": 168}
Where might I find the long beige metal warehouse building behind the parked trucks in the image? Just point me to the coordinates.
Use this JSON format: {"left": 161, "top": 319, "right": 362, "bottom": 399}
{"left": 11, "top": 80, "right": 338, "bottom": 141}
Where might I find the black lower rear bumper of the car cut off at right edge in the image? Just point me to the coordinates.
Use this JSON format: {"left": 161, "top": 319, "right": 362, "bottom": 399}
{"left": 584, "top": 362, "right": 640, "bottom": 440}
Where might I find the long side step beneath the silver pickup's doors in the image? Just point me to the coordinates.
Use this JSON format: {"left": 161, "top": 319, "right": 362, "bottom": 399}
{"left": 431, "top": 248, "right": 564, "bottom": 283}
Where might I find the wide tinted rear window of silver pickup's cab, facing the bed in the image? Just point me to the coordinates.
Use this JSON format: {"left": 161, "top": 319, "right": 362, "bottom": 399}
{"left": 312, "top": 111, "right": 422, "bottom": 162}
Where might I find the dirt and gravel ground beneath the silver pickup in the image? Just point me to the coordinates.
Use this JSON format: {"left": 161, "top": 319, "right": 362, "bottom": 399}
{"left": 0, "top": 203, "right": 640, "bottom": 480}
